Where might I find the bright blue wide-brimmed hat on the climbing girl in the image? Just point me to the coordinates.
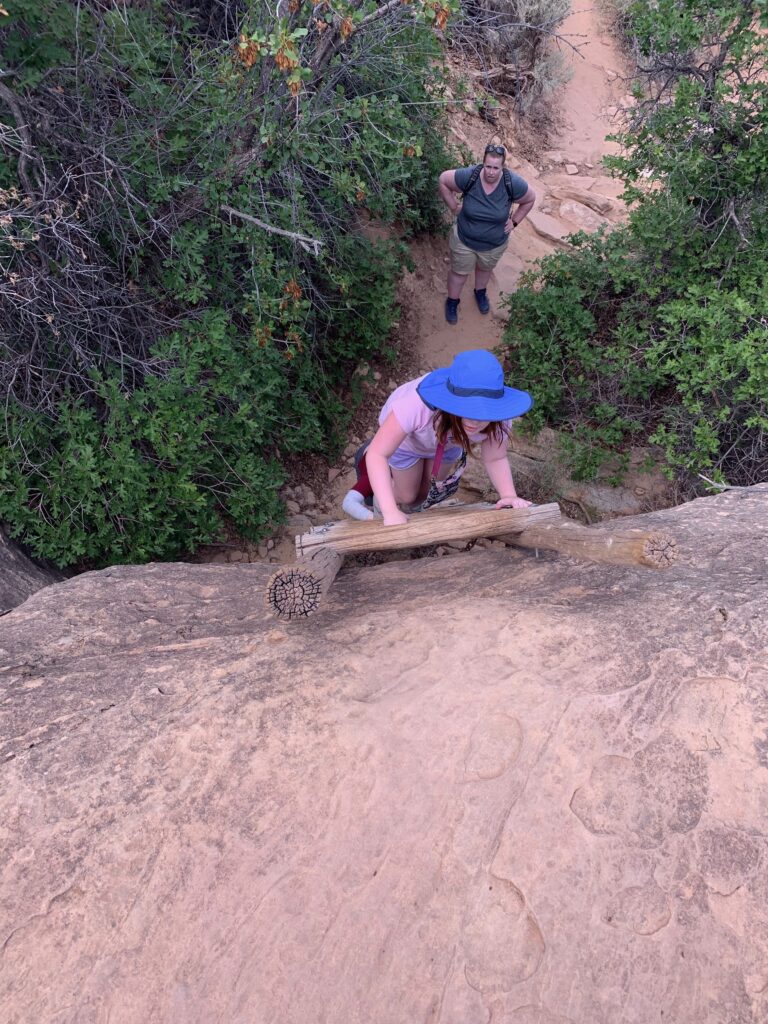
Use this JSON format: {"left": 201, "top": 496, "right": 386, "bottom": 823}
{"left": 416, "top": 348, "right": 534, "bottom": 422}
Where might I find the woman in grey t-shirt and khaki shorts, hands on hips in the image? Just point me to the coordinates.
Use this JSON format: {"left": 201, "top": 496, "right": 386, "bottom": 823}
{"left": 439, "top": 144, "right": 536, "bottom": 324}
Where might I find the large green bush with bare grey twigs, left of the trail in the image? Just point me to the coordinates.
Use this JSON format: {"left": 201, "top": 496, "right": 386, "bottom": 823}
{"left": 0, "top": 0, "right": 452, "bottom": 565}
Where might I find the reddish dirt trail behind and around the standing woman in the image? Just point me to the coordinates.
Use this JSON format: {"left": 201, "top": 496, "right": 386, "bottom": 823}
{"left": 403, "top": 7, "right": 627, "bottom": 369}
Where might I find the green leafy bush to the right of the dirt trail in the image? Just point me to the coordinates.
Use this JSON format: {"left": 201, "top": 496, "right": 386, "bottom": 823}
{"left": 506, "top": 0, "right": 768, "bottom": 484}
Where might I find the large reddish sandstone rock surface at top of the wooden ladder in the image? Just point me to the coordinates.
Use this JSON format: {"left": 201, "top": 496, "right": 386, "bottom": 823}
{"left": 0, "top": 489, "right": 768, "bottom": 1024}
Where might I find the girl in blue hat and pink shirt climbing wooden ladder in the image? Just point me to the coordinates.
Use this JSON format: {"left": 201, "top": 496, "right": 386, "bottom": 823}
{"left": 342, "top": 349, "right": 534, "bottom": 526}
